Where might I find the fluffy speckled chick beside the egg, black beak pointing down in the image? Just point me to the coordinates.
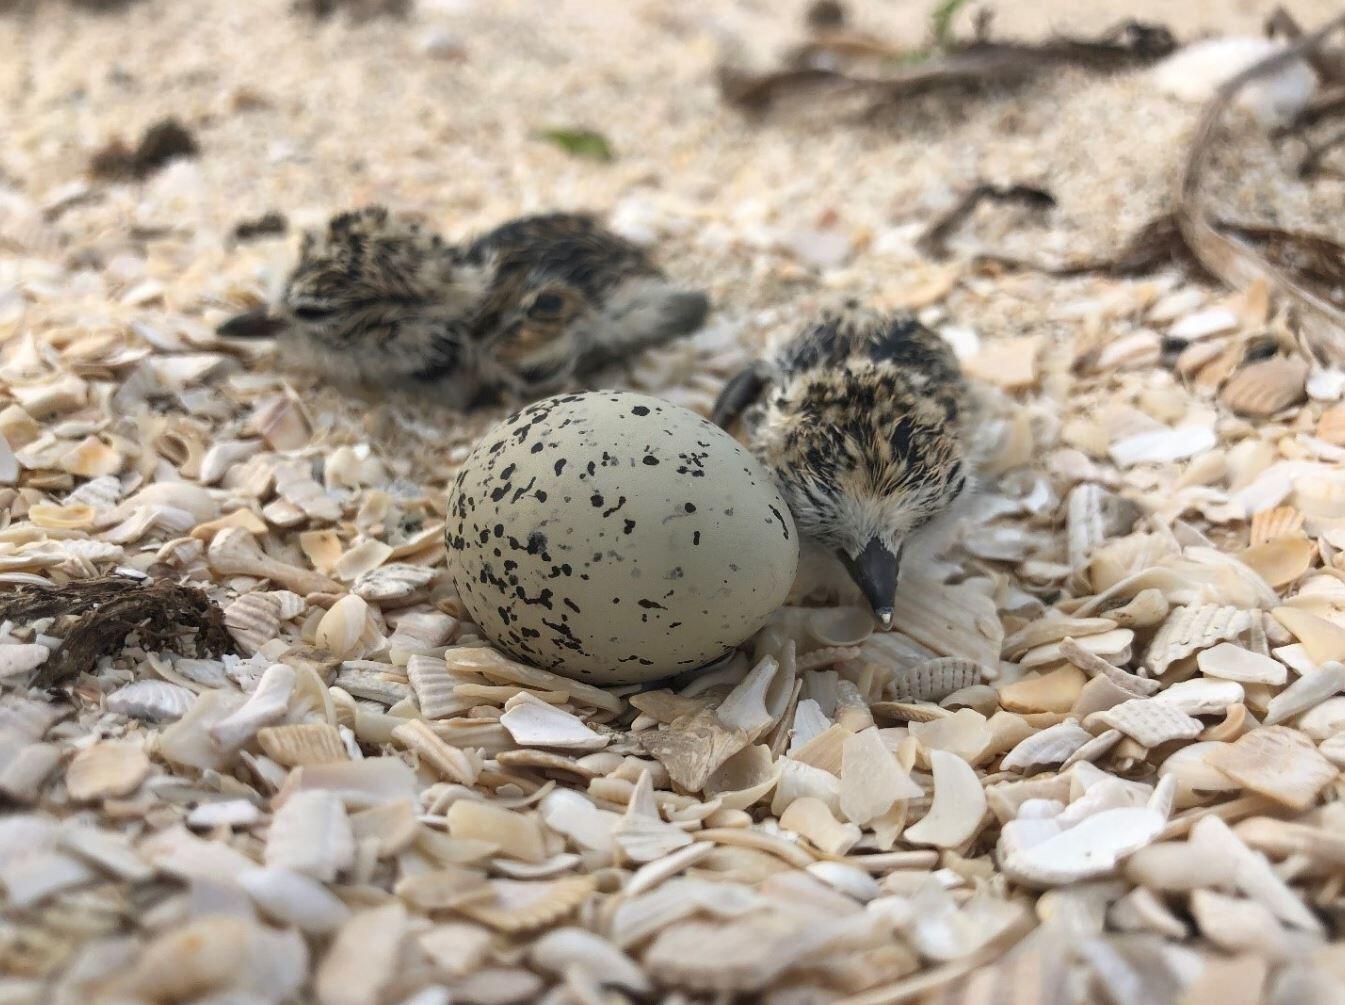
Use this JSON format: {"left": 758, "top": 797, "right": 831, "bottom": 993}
{"left": 713, "top": 311, "right": 971, "bottom": 627}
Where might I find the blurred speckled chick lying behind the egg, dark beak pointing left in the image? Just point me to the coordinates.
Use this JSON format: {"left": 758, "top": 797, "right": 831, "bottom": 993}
{"left": 219, "top": 206, "right": 709, "bottom": 408}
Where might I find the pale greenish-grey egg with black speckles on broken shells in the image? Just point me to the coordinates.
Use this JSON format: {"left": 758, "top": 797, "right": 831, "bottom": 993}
{"left": 445, "top": 392, "right": 799, "bottom": 683}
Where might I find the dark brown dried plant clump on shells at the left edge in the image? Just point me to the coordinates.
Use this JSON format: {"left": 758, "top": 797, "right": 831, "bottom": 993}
{"left": 0, "top": 576, "right": 234, "bottom": 687}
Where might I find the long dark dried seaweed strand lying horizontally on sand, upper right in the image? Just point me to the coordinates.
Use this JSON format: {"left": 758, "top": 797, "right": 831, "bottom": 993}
{"left": 718, "top": 20, "right": 1177, "bottom": 112}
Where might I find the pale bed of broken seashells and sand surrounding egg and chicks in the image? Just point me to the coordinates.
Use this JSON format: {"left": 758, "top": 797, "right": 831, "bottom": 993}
{"left": 0, "top": 0, "right": 1345, "bottom": 1005}
